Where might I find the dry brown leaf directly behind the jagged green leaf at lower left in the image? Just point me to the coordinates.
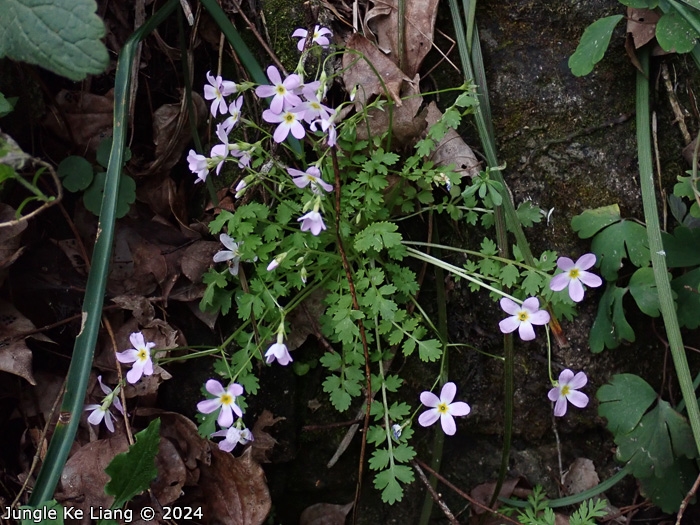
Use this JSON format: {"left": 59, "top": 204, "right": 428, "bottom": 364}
{"left": 56, "top": 435, "right": 129, "bottom": 524}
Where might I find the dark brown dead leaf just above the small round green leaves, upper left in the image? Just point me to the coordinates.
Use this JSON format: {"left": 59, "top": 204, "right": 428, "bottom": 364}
{"left": 45, "top": 89, "right": 114, "bottom": 152}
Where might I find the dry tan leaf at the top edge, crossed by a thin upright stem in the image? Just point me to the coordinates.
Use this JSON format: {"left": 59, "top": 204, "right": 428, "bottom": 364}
{"left": 364, "top": 0, "right": 438, "bottom": 77}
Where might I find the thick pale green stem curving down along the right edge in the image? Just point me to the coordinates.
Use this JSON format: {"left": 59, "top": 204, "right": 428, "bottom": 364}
{"left": 637, "top": 47, "right": 700, "bottom": 458}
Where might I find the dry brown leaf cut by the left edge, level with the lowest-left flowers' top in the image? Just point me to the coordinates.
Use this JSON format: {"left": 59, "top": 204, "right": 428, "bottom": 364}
{"left": 0, "top": 299, "right": 51, "bottom": 385}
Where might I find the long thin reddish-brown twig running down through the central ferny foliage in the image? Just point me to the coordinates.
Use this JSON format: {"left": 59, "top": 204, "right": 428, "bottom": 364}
{"left": 331, "top": 147, "right": 372, "bottom": 523}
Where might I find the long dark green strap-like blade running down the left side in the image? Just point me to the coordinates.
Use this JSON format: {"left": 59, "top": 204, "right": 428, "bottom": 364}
{"left": 29, "top": 0, "right": 179, "bottom": 506}
